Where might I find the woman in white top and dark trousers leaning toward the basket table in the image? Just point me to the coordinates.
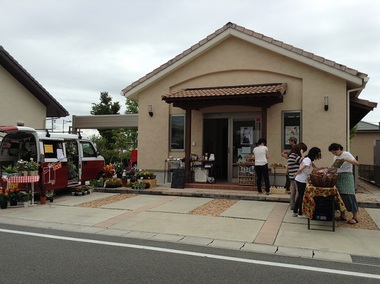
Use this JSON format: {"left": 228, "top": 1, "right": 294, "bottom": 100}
{"left": 293, "top": 147, "right": 321, "bottom": 218}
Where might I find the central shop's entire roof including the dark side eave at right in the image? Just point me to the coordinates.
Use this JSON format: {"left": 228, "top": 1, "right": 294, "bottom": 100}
{"left": 122, "top": 22, "right": 377, "bottom": 127}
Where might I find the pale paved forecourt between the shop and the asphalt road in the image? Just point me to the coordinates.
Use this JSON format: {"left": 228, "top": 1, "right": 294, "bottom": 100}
{"left": 0, "top": 180, "right": 380, "bottom": 266}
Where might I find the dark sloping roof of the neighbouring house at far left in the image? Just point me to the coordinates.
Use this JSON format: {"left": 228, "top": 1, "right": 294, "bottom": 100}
{"left": 0, "top": 45, "right": 69, "bottom": 117}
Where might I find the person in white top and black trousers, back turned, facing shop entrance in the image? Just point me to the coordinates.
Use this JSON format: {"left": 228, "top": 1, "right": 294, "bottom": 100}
{"left": 253, "top": 138, "right": 270, "bottom": 195}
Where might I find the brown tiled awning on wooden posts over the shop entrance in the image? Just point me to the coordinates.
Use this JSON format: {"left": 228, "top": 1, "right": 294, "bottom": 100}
{"left": 162, "top": 83, "right": 287, "bottom": 109}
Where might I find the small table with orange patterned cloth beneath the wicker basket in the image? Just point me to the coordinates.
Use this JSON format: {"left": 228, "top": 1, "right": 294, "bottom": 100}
{"left": 302, "top": 185, "right": 346, "bottom": 232}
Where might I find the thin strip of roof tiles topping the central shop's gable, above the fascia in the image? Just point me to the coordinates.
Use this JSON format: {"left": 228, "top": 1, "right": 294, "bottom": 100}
{"left": 122, "top": 22, "right": 368, "bottom": 94}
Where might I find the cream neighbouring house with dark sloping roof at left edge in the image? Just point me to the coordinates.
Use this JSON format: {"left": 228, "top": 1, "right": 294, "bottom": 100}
{"left": 0, "top": 46, "right": 69, "bottom": 129}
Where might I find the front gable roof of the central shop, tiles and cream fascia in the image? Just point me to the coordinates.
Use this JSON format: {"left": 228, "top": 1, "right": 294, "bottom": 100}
{"left": 122, "top": 22, "right": 369, "bottom": 97}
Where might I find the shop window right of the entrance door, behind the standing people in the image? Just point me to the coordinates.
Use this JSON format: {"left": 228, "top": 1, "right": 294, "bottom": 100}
{"left": 281, "top": 111, "right": 302, "bottom": 150}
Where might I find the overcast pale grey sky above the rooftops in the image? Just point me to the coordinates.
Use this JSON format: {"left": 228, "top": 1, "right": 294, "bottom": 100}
{"left": 0, "top": 0, "right": 380, "bottom": 131}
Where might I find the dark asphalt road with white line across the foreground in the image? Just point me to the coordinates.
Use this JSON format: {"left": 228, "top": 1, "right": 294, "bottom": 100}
{"left": 0, "top": 225, "right": 380, "bottom": 284}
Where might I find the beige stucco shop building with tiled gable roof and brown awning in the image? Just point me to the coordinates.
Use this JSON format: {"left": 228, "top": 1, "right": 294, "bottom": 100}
{"left": 123, "top": 23, "right": 376, "bottom": 185}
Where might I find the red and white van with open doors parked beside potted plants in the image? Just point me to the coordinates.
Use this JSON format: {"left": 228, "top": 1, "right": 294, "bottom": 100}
{"left": 0, "top": 126, "right": 105, "bottom": 195}
